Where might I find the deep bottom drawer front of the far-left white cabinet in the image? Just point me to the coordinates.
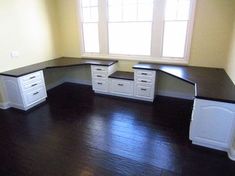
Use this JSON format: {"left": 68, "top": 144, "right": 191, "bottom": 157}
{"left": 24, "top": 86, "right": 46, "bottom": 106}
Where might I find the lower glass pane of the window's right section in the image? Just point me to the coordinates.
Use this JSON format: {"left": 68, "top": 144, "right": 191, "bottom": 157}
{"left": 163, "top": 21, "right": 187, "bottom": 58}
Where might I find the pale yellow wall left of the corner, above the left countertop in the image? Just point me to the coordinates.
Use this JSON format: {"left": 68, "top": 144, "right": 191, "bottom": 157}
{"left": 0, "top": 0, "right": 61, "bottom": 102}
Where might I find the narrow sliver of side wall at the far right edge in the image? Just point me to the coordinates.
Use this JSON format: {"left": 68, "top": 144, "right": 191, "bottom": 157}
{"left": 225, "top": 14, "right": 235, "bottom": 84}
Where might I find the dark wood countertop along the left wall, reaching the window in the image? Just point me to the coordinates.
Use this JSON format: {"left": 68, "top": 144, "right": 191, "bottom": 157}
{"left": 0, "top": 57, "right": 117, "bottom": 77}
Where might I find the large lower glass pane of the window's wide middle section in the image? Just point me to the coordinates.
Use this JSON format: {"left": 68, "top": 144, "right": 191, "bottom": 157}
{"left": 109, "top": 22, "right": 152, "bottom": 55}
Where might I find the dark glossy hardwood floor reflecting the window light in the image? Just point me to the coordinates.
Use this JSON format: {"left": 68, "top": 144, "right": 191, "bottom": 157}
{"left": 0, "top": 83, "right": 235, "bottom": 176}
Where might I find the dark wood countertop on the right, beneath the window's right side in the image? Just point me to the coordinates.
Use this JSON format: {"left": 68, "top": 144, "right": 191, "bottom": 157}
{"left": 133, "top": 63, "right": 235, "bottom": 103}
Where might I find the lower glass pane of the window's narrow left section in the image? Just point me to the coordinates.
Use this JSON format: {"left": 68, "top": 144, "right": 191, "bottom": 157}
{"left": 83, "top": 23, "right": 99, "bottom": 52}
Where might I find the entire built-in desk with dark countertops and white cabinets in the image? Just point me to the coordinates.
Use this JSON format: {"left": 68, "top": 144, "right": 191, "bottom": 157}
{"left": 0, "top": 57, "right": 235, "bottom": 160}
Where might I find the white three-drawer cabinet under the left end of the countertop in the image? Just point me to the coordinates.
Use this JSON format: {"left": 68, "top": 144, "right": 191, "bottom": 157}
{"left": 3, "top": 71, "right": 47, "bottom": 110}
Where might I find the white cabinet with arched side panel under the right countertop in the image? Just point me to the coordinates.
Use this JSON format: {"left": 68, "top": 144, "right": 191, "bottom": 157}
{"left": 190, "top": 99, "right": 235, "bottom": 151}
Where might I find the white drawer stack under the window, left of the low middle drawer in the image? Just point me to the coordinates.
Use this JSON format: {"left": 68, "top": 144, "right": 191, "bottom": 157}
{"left": 91, "top": 64, "right": 117, "bottom": 93}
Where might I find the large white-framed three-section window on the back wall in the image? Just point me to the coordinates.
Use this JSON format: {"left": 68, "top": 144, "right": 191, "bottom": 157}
{"left": 80, "top": 0, "right": 196, "bottom": 62}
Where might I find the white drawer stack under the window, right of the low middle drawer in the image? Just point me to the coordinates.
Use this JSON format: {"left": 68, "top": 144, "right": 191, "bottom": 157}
{"left": 134, "top": 69, "right": 156, "bottom": 102}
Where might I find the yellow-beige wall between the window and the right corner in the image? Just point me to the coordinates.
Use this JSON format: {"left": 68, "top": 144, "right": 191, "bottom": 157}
{"left": 190, "top": 0, "right": 235, "bottom": 68}
